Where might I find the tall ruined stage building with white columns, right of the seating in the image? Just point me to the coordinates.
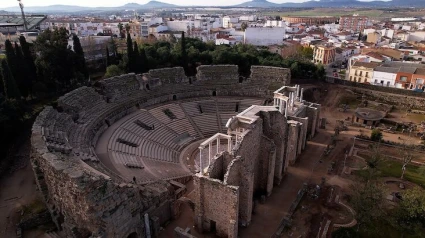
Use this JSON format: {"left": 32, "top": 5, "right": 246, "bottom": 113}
{"left": 194, "top": 85, "right": 320, "bottom": 237}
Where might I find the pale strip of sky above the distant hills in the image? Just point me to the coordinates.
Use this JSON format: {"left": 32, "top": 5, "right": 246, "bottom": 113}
{"left": 0, "top": 0, "right": 307, "bottom": 8}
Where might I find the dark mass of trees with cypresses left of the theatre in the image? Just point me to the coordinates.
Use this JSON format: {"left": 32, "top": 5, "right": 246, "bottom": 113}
{"left": 0, "top": 28, "right": 89, "bottom": 168}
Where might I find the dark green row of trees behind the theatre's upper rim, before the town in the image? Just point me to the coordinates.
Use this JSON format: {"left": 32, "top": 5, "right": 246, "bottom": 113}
{"left": 106, "top": 33, "right": 325, "bottom": 79}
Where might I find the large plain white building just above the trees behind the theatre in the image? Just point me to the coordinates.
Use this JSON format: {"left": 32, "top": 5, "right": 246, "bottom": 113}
{"left": 244, "top": 27, "right": 286, "bottom": 46}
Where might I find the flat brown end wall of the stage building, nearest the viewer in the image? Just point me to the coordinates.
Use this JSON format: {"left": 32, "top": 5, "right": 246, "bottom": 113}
{"left": 193, "top": 174, "right": 239, "bottom": 238}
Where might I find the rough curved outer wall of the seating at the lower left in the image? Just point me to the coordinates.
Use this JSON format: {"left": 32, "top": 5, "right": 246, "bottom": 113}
{"left": 31, "top": 124, "right": 173, "bottom": 237}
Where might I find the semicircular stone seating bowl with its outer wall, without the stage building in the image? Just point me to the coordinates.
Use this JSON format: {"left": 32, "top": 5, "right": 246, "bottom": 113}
{"left": 31, "top": 65, "right": 290, "bottom": 237}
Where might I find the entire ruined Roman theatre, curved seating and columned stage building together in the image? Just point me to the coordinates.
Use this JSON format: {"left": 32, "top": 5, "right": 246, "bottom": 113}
{"left": 31, "top": 65, "right": 320, "bottom": 238}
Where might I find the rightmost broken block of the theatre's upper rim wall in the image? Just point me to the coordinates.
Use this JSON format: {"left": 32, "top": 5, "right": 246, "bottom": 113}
{"left": 250, "top": 65, "right": 291, "bottom": 85}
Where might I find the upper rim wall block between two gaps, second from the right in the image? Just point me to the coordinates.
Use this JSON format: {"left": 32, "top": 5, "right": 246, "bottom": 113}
{"left": 196, "top": 65, "right": 239, "bottom": 83}
